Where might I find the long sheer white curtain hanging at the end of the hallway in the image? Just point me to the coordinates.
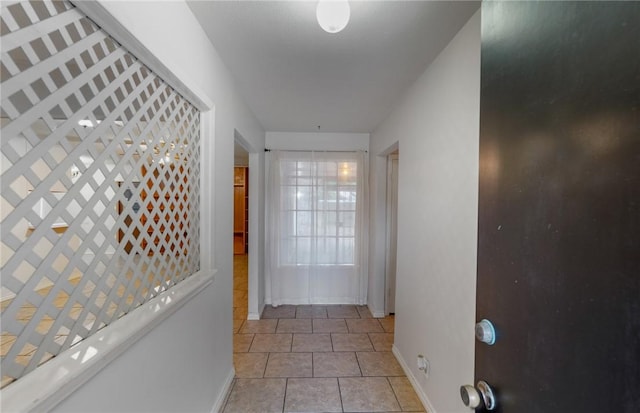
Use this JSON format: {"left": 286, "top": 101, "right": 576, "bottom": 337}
{"left": 266, "top": 151, "right": 367, "bottom": 306}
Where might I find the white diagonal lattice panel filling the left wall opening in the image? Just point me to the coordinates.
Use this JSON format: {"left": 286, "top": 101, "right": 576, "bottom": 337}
{"left": 0, "top": 1, "right": 200, "bottom": 386}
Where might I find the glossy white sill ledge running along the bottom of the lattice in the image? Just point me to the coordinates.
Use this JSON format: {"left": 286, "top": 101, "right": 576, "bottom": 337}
{"left": 2, "top": 271, "right": 215, "bottom": 412}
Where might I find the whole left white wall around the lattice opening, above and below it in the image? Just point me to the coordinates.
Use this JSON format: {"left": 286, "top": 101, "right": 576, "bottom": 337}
{"left": 54, "top": 0, "right": 264, "bottom": 412}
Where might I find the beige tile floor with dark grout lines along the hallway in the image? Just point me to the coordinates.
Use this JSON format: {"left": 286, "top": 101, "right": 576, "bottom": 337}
{"left": 228, "top": 255, "right": 425, "bottom": 413}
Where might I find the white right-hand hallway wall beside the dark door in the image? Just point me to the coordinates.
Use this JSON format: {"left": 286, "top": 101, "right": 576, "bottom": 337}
{"left": 370, "top": 12, "right": 480, "bottom": 413}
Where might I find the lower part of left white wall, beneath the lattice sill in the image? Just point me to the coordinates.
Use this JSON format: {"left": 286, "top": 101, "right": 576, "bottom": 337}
{"left": 53, "top": 280, "right": 222, "bottom": 413}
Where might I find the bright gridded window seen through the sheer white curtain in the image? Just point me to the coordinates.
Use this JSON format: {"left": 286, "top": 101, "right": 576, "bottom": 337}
{"left": 280, "top": 156, "right": 358, "bottom": 265}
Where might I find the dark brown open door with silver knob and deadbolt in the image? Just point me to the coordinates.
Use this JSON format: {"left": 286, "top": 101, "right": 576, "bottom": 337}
{"left": 475, "top": 2, "right": 640, "bottom": 413}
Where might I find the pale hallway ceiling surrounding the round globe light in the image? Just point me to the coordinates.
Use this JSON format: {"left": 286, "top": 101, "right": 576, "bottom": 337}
{"left": 187, "top": 1, "right": 480, "bottom": 133}
